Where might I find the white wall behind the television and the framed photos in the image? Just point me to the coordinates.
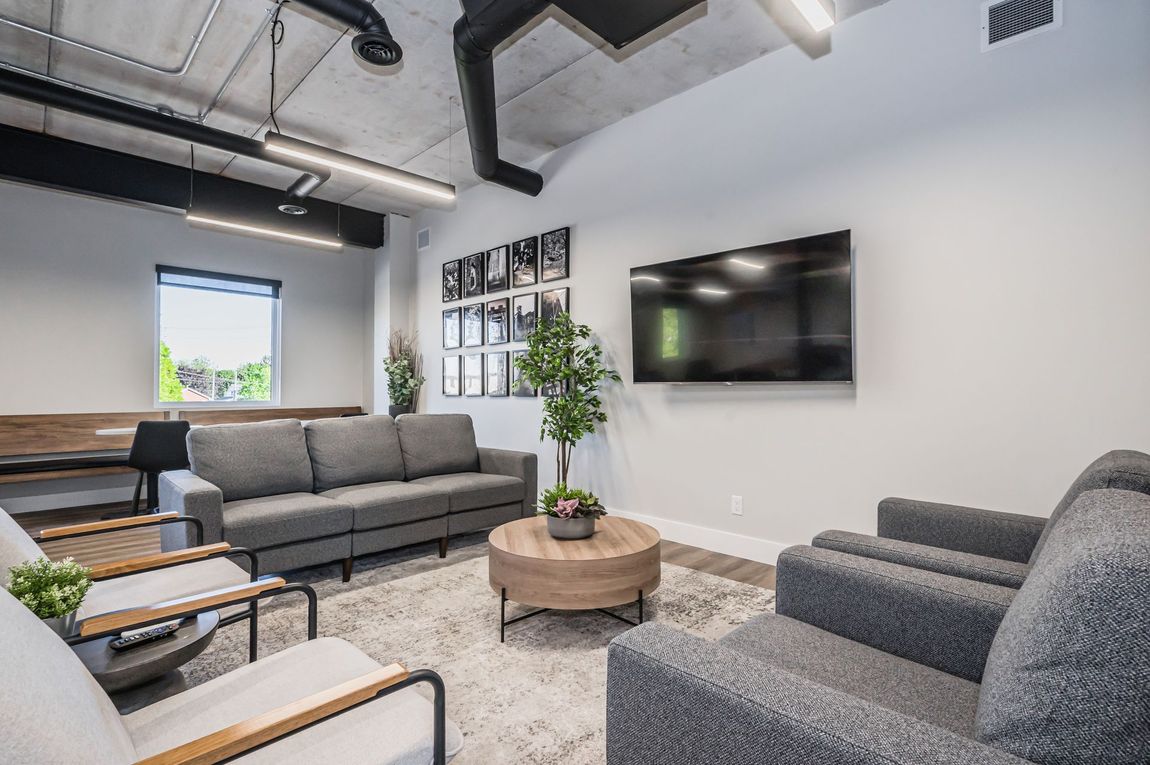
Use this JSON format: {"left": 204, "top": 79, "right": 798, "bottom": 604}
{"left": 416, "top": 0, "right": 1150, "bottom": 560}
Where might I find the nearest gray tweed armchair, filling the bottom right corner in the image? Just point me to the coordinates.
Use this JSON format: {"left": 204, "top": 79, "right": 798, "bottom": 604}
{"left": 607, "top": 490, "right": 1150, "bottom": 765}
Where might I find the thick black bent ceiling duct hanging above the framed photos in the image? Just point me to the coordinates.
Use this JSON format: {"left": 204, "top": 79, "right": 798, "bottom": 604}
{"left": 455, "top": 0, "right": 703, "bottom": 197}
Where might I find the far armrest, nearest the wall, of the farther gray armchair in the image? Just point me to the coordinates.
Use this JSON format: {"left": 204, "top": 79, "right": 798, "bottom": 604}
{"left": 879, "top": 497, "right": 1047, "bottom": 563}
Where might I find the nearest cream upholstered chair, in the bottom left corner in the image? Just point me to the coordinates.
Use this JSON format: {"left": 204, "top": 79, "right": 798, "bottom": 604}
{"left": 0, "top": 591, "right": 462, "bottom": 765}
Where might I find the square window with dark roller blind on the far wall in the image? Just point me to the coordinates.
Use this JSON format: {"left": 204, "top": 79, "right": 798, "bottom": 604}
{"left": 155, "top": 266, "right": 281, "bottom": 406}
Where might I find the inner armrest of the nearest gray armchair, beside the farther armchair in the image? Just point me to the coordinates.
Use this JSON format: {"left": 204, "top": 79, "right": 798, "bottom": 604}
{"left": 775, "top": 545, "right": 1018, "bottom": 682}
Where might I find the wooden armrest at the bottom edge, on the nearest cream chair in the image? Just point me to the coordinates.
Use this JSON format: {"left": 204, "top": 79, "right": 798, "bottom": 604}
{"left": 137, "top": 664, "right": 409, "bottom": 765}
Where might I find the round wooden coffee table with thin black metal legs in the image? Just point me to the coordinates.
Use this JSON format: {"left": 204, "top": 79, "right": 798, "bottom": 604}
{"left": 488, "top": 515, "right": 659, "bottom": 642}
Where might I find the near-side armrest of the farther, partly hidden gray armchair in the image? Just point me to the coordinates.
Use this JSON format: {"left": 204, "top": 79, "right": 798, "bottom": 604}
{"left": 811, "top": 530, "right": 1030, "bottom": 590}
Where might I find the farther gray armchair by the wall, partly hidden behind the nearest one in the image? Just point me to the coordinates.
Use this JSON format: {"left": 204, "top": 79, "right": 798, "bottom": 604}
{"left": 812, "top": 451, "right": 1150, "bottom": 589}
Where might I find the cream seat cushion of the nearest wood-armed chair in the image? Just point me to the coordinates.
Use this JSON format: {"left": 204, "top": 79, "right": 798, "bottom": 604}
{"left": 124, "top": 637, "right": 462, "bottom": 765}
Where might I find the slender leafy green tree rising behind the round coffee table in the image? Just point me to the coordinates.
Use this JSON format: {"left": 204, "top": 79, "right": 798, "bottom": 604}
{"left": 515, "top": 313, "right": 620, "bottom": 485}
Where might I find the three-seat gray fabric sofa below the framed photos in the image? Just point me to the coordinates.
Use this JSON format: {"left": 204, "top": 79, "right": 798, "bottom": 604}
{"left": 160, "top": 414, "right": 538, "bottom": 581}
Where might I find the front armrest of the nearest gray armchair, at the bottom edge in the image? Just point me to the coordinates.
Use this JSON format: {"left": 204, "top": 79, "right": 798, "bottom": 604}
{"left": 607, "top": 624, "right": 1026, "bottom": 765}
